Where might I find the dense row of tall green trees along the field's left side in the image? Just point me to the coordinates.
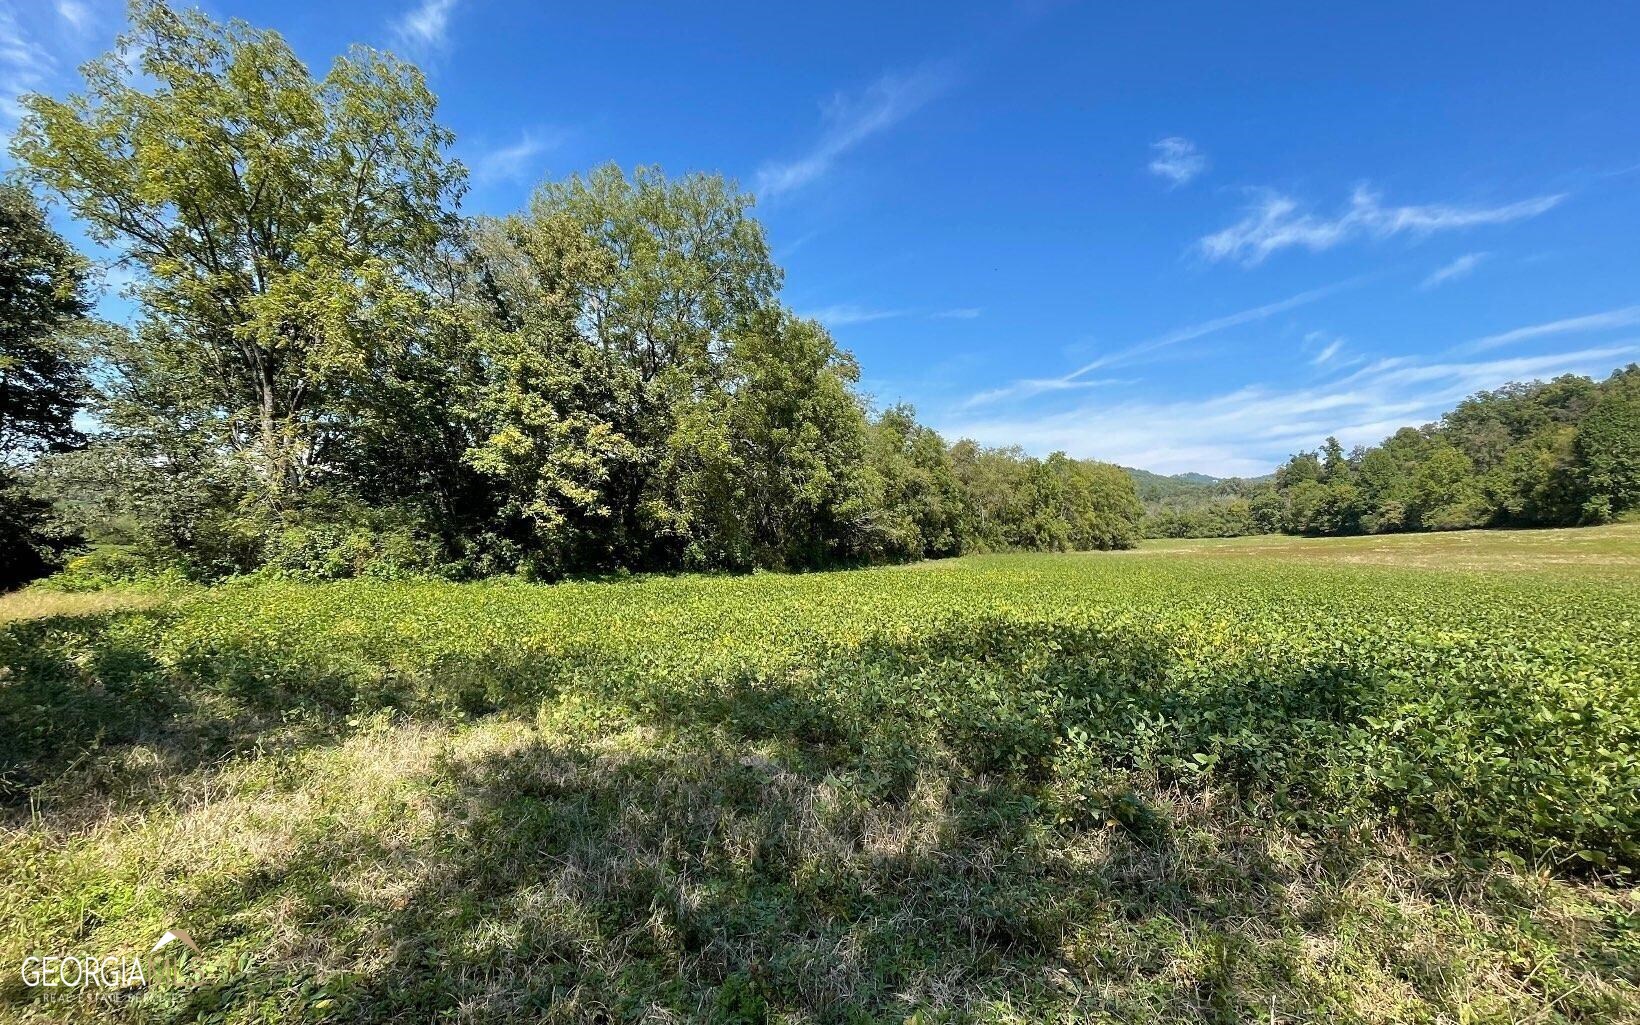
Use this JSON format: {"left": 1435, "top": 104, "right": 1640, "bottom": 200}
{"left": 0, "top": 0, "right": 1141, "bottom": 582}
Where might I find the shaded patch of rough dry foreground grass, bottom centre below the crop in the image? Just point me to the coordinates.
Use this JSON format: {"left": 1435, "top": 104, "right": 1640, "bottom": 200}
{"left": 151, "top": 735, "right": 1384, "bottom": 1023}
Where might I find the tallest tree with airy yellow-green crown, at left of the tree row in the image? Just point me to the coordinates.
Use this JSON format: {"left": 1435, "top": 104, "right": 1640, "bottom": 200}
{"left": 13, "top": 0, "right": 464, "bottom": 510}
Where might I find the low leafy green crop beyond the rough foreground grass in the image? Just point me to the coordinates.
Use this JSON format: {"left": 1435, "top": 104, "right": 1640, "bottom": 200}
{"left": 15, "top": 534, "right": 1640, "bottom": 868}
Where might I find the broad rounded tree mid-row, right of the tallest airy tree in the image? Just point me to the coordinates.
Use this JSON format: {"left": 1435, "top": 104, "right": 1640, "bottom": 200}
{"left": 469, "top": 167, "right": 793, "bottom": 567}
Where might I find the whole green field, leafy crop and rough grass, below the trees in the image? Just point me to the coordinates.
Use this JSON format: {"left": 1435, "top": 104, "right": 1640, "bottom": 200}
{"left": 0, "top": 526, "right": 1640, "bottom": 1022}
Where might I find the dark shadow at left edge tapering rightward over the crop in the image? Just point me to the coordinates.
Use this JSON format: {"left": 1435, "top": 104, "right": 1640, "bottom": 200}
{"left": 0, "top": 608, "right": 590, "bottom": 815}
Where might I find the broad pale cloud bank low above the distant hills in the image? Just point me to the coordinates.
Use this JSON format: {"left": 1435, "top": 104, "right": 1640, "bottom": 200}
{"left": 936, "top": 339, "right": 1640, "bottom": 476}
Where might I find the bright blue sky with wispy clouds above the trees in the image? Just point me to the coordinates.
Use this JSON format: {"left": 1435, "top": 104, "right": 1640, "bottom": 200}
{"left": 0, "top": 0, "right": 1640, "bottom": 474}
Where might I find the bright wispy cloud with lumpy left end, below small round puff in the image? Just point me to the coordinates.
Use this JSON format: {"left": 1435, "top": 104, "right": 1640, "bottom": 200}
{"left": 1196, "top": 185, "right": 1566, "bottom": 266}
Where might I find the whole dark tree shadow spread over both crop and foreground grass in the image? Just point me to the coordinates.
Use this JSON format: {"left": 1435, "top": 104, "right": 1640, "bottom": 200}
{"left": 0, "top": 603, "right": 1615, "bottom": 1023}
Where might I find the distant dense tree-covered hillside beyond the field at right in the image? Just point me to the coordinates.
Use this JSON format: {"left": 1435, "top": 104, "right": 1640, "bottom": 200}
{"left": 1145, "top": 364, "right": 1640, "bottom": 536}
